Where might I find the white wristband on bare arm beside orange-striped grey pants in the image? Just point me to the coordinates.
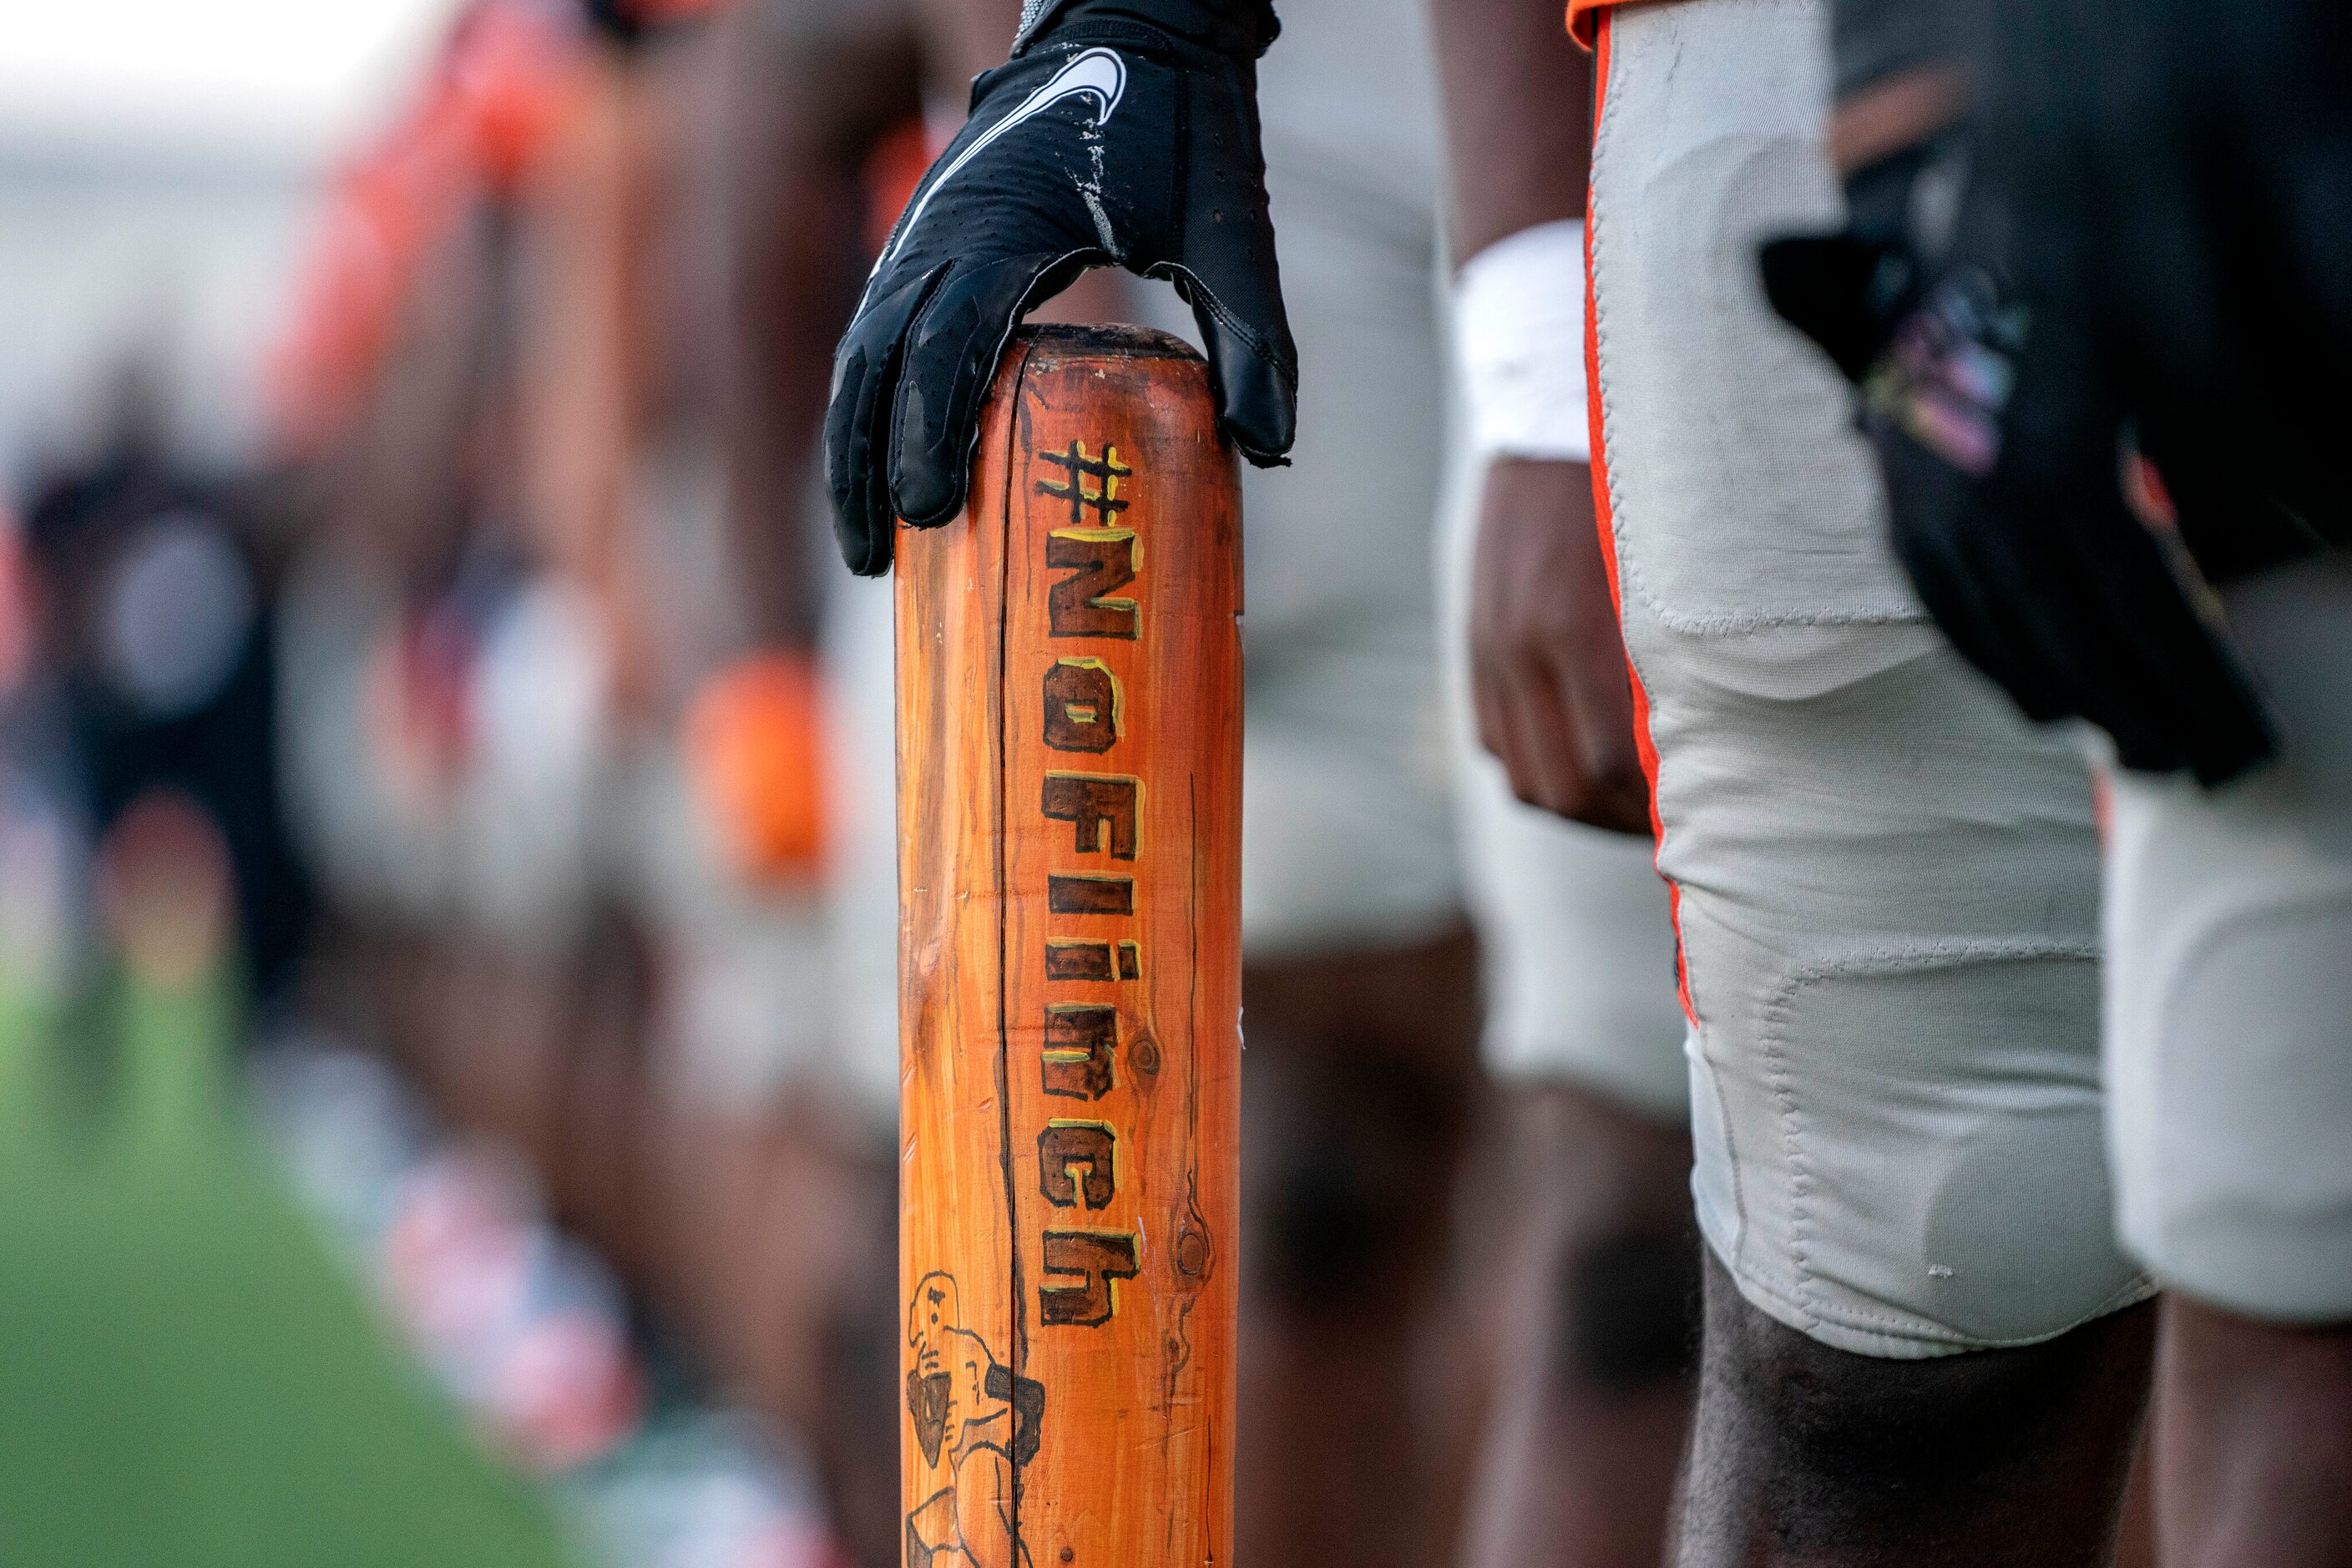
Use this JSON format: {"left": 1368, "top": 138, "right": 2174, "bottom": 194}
{"left": 1454, "top": 219, "right": 1592, "bottom": 463}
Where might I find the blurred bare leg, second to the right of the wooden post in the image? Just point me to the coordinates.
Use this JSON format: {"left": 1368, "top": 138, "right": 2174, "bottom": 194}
{"left": 1463, "top": 1086, "right": 1698, "bottom": 1568}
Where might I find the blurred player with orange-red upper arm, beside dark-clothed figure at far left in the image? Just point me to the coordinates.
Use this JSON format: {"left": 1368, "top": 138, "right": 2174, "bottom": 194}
{"left": 276, "top": 3, "right": 581, "bottom": 1142}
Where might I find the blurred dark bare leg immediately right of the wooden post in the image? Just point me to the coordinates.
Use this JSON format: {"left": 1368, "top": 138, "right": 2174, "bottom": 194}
{"left": 1235, "top": 931, "right": 1479, "bottom": 1568}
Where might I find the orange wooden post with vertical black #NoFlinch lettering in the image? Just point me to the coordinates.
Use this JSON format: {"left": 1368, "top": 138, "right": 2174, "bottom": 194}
{"left": 896, "top": 326, "right": 1242, "bottom": 1568}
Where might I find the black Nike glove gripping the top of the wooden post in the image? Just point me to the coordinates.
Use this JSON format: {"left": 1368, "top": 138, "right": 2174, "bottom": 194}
{"left": 826, "top": 0, "right": 1298, "bottom": 576}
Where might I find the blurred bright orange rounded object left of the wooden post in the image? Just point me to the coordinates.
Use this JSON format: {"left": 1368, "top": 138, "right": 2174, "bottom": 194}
{"left": 685, "top": 654, "right": 826, "bottom": 886}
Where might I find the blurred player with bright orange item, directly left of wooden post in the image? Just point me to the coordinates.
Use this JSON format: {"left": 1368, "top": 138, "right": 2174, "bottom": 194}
{"left": 510, "top": 3, "right": 896, "bottom": 1540}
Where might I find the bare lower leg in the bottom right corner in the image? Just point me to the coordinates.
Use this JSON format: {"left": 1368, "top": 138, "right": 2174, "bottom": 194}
{"left": 2154, "top": 1295, "right": 2352, "bottom": 1568}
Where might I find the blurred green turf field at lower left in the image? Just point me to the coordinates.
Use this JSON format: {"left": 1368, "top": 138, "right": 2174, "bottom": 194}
{"left": 0, "top": 978, "right": 583, "bottom": 1568}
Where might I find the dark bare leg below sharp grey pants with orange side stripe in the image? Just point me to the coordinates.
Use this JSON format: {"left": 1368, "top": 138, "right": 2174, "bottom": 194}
{"left": 1677, "top": 1253, "right": 2154, "bottom": 1568}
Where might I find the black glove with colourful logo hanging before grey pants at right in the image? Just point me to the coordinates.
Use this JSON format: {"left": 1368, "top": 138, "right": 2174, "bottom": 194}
{"left": 1762, "top": 132, "right": 2274, "bottom": 783}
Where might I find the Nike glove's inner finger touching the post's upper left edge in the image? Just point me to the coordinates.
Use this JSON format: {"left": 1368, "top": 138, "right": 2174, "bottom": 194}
{"left": 889, "top": 251, "right": 1096, "bottom": 529}
